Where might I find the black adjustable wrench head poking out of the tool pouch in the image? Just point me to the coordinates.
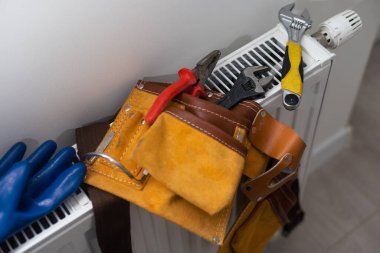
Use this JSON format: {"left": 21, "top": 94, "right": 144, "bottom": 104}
{"left": 218, "top": 66, "right": 273, "bottom": 109}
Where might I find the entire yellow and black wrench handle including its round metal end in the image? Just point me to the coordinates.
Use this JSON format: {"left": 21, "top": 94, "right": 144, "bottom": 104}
{"left": 281, "top": 40, "right": 303, "bottom": 110}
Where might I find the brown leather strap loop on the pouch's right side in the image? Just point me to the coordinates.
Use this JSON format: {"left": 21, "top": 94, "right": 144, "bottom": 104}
{"left": 241, "top": 109, "right": 306, "bottom": 202}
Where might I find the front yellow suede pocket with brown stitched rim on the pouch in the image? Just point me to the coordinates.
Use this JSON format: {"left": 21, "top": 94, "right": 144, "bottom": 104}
{"left": 131, "top": 107, "right": 247, "bottom": 215}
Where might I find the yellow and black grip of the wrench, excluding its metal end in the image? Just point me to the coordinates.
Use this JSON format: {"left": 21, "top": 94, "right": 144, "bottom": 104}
{"left": 281, "top": 40, "right": 303, "bottom": 96}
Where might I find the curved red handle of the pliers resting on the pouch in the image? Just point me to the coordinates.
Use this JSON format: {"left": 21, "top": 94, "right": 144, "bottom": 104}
{"left": 145, "top": 68, "right": 197, "bottom": 125}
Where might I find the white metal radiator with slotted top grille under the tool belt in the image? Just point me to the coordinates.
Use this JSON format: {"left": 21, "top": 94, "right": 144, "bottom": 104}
{"left": 0, "top": 25, "right": 334, "bottom": 253}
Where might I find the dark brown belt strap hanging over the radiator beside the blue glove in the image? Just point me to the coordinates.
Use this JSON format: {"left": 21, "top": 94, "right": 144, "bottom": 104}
{"left": 75, "top": 122, "right": 132, "bottom": 253}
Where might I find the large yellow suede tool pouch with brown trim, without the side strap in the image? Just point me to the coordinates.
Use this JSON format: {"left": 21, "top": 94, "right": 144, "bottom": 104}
{"left": 86, "top": 81, "right": 257, "bottom": 244}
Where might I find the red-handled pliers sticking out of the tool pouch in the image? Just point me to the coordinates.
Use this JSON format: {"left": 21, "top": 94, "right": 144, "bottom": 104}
{"left": 145, "top": 50, "right": 221, "bottom": 125}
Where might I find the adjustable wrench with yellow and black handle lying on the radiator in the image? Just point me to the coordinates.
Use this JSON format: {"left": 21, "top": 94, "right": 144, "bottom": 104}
{"left": 278, "top": 3, "right": 311, "bottom": 110}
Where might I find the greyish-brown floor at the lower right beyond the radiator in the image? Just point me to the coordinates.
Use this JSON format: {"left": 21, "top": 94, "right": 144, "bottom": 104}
{"left": 267, "top": 43, "right": 380, "bottom": 253}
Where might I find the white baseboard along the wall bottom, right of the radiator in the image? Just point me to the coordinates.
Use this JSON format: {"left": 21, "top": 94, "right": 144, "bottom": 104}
{"left": 308, "top": 126, "right": 352, "bottom": 175}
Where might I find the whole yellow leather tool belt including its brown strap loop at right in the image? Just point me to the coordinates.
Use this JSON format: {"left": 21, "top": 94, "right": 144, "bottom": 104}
{"left": 85, "top": 81, "right": 305, "bottom": 249}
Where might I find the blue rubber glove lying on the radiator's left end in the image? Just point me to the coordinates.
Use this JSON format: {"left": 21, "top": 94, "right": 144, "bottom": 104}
{"left": 0, "top": 141, "right": 86, "bottom": 242}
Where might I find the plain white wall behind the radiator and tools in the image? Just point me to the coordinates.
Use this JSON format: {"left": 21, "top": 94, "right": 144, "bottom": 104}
{"left": 0, "top": 0, "right": 379, "bottom": 156}
